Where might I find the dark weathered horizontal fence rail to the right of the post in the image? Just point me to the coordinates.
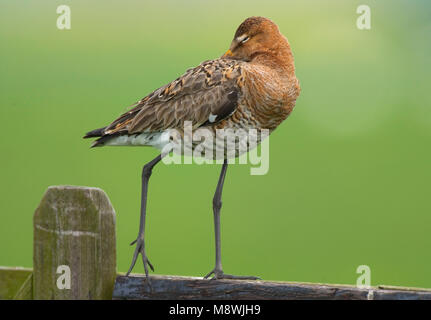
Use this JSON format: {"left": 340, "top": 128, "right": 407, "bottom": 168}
{"left": 113, "top": 275, "right": 431, "bottom": 300}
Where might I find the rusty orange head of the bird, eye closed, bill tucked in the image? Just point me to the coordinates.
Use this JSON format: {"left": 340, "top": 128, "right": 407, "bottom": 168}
{"left": 222, "top": 17, "right": 290, "bottom": 62}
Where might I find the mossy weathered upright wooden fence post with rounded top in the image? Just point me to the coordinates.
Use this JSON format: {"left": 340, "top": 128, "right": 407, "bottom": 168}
{"left": 33, "top": 186, "right": 116, "bottom": 299}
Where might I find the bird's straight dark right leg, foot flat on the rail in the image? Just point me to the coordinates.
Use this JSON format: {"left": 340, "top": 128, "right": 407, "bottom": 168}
{"left": 204, "top": 159, "right": 259, "bottom": 280}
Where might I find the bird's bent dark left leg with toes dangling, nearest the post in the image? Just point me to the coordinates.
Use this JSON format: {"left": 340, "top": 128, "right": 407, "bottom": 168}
{"left": 126, "top": 154, "right": 165, "bottom": 281}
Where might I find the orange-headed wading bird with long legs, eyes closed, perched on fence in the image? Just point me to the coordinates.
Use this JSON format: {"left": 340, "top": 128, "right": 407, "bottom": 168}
{"left": 84, "top": 16, "right": 301, "bottom": 281}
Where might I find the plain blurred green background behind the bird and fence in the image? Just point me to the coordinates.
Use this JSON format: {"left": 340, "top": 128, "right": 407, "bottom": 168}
{"left": 0, "top": 0, "right": 431, "bottom": 287}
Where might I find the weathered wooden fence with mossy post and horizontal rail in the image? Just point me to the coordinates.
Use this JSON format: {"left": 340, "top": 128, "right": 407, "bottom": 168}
{"left": 0, "top": 186, "right": 431, "bottom": 300}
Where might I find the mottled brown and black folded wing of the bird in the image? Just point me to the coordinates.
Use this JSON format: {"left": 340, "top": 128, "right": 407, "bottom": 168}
{"left": 104, "top": 59, "right": 243, "bottom": 135}
